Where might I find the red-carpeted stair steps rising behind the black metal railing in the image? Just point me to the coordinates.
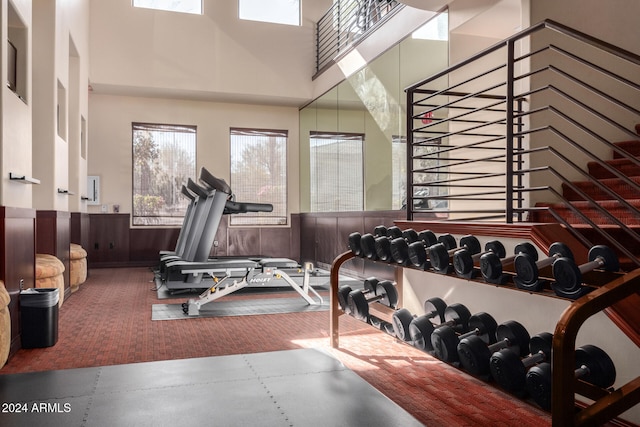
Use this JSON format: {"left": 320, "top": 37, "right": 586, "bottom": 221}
{"left": 531, "top": 124, "right": 640, "bottom": 271}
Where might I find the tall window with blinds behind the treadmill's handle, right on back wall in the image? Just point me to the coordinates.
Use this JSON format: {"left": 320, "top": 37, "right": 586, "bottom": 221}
{"left": 229, "top": 128, "right": 288, "bottom": 225}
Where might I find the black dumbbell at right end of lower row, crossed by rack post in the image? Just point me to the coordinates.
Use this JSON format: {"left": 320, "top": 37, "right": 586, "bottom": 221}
{"left": 526, "top": 345, "right": 616, "bottom": 411}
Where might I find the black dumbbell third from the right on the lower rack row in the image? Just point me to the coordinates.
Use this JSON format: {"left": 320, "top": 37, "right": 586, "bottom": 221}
{"left": 458, "top": 320, "right": 531, "bottom": 376}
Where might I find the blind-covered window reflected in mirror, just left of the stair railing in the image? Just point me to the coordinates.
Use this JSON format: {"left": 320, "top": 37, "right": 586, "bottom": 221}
{"left": 309, "top": 132, "right": 364, "bottom": 212}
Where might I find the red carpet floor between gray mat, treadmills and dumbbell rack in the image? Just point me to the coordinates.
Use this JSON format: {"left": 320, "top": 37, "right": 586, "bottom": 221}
{"left": 0, "top": 268, "right": 550, "bottom": 426}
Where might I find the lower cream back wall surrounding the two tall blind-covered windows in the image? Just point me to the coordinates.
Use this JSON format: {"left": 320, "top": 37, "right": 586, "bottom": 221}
{"left": 88, "top": 93, "right": 299, "bottom": 219}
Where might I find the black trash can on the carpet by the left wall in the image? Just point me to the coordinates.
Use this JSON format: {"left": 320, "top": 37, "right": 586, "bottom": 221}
{"left": 20, "top": 288, "right": 60, "bottom": 348}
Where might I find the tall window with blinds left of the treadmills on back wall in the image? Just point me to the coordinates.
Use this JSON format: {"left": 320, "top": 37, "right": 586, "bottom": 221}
{"left": 132, "top": 123, "right": 196, "bottom": 225}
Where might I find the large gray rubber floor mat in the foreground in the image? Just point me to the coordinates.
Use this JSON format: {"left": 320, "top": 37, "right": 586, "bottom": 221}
{"left": 0, "top": 349, "right": 421, "bottom": 427}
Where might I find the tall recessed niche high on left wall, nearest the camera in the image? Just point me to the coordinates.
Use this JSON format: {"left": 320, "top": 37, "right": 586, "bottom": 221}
{"left": 5, "top": 1, "right": 29, "bottom": 102}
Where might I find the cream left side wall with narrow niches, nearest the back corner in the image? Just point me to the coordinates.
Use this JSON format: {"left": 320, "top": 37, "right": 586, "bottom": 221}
{"left": 32, "top": 0, "right": 89, "bottom": 211}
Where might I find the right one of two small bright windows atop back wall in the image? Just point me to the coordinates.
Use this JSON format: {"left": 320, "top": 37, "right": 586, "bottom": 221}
{"left": 238, "top": 0, "right": 300, "bottom": 25}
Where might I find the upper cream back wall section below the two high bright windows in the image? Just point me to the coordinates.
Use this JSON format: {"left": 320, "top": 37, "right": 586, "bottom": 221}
{"left": 91, "top": 0, "right": 331, "bottom": 105}
